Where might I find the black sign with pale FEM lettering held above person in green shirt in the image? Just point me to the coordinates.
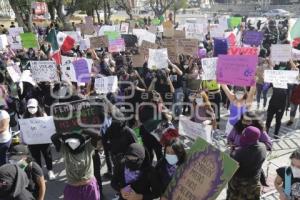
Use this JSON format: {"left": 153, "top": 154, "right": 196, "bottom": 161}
{"left": 51, "top": 100, "right": 104, "bottom": 133}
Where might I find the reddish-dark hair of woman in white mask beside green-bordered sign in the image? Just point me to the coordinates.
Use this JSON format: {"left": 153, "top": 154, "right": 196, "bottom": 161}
{"left": 164, "top": 138, "right": 186, "bottom": 166}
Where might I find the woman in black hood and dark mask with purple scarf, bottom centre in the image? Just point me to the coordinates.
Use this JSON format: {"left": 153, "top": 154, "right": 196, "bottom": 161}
{"left": 111, "top": 143, "right": 160, "bottom": 200}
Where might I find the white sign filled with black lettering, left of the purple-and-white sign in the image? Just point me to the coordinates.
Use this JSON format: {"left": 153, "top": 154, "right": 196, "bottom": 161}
{"left": 30, "top": 61, "right": 59, "bottom": 83}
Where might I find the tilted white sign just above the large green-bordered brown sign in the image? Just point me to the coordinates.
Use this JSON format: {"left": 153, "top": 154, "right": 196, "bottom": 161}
{"left": 179, "top": 116, "right": 212, "bottom": 143}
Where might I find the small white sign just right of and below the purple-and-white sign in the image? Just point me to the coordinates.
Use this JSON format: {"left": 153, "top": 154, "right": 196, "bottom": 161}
{"left": 95, "top": 76, "right": 118, "bottom": 94}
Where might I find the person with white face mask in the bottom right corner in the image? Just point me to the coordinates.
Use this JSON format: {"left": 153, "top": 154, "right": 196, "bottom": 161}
{"left": 274, "top": 149, "right": 300, "bottom": 200}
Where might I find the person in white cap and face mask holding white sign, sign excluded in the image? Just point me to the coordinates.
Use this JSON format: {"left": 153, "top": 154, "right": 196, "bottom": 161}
{"left": 23, "top": 99, "right": 56, "bottom": 180}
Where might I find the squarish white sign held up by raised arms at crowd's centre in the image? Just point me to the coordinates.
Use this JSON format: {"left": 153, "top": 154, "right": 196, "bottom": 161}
{"left": 148, "top": 49, "right": 168, "bottom": 69}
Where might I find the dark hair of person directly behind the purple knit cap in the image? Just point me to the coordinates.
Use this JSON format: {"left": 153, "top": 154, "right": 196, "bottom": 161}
{"left": 234, "top": 111, "right": 265, "bottom": 135}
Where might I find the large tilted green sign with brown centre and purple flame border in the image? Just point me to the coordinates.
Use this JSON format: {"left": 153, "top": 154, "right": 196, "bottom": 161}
{"left": 163, "top": 138, "right": 238, "bottom": 200}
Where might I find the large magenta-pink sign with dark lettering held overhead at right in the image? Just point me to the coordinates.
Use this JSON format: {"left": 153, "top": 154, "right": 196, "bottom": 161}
{"left": 217, "top": 55, "right": 258, "bottom": 86}
